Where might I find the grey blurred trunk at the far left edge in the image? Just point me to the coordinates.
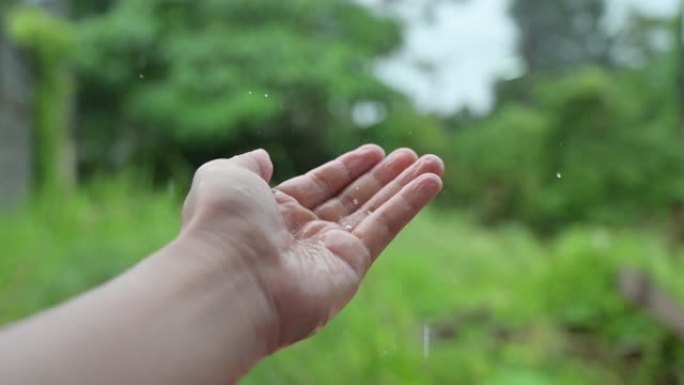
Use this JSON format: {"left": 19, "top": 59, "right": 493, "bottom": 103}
{"left": 0, "top": 18, "right": 33, "bottom": 208}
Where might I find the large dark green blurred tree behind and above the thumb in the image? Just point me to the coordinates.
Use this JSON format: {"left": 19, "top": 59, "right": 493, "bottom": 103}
{"left": 73, "top": 0, "right": 428, "bottom": 180}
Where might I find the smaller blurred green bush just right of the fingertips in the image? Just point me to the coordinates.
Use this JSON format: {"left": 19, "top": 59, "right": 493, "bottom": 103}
{"left": 447, "top": 103, "right": 548, "bottom": 223}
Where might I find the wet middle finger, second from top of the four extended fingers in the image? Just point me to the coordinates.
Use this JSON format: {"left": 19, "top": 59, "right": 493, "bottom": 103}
{"left": 314, "top": 149, "right": 418, "bottom": 222}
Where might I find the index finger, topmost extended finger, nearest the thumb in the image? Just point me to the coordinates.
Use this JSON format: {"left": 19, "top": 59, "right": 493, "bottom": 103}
{"left": 277, "top": 145, "right": 385, "bottom": 209}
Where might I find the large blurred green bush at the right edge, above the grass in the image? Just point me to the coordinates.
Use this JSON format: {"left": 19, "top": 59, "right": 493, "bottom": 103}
{"left": 540, "top": 70, "right": 684, "bottom": 224}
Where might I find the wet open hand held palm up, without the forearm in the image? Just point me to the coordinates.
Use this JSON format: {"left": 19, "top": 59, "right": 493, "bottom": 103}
{"left": 182, "top": 145, "right": 444, "bottom": 350}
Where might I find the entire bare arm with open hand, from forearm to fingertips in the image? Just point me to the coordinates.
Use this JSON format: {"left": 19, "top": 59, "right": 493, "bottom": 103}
{"left": 0, "top": 145, "right": 444, "bottom": 385}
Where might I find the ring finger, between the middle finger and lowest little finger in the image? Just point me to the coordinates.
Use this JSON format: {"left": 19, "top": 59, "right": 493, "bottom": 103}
{"left": 342, "top": 155, "right": 444, "bottom": 227}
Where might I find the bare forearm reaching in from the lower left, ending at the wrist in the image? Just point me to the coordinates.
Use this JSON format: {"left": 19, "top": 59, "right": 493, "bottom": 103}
{"left": 0, "top": 236, "right": 272, "bottom": 385}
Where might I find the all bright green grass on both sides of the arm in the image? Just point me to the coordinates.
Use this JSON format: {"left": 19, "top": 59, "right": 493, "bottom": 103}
{"left": 0, "top": 181, "right": 684, "bottom": 385}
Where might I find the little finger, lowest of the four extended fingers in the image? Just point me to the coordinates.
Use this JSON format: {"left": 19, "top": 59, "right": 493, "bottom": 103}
{"left": 353, "top": 174, "right": 442, "bottom": 259}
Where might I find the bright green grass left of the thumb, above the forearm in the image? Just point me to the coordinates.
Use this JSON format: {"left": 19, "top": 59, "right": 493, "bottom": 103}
{"left": 0, "top": 178, "right": 179, "bottom": 323}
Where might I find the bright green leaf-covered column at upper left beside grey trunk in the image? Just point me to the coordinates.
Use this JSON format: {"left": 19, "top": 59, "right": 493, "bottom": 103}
{"left": 8, "top": 0, "right": 75, "bottom": 194}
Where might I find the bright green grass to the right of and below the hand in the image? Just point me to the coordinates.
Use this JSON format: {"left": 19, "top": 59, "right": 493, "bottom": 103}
{"left": 245, "top": 213, "right": 681, "bottom": 385}
